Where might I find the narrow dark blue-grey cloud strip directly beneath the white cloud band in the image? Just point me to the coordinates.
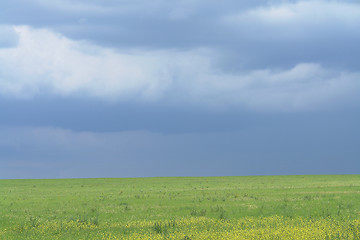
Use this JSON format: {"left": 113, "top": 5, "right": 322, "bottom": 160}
{"left": 0, "top": 97, "right": 360, "bottom": 134}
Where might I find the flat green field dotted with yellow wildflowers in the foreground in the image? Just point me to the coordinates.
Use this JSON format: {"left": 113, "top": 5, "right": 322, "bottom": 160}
{"left": 0, "top": 175, "right": 360, "bottom": 239}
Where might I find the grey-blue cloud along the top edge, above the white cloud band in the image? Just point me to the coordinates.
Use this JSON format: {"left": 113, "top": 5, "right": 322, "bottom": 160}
{"left": 0, "top": 0, "right": 360, "bottom": 72}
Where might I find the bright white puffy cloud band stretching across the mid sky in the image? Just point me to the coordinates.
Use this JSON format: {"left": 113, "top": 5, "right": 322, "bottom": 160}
{"left": 0, "top": 26, "right": 360, "bottom": 110}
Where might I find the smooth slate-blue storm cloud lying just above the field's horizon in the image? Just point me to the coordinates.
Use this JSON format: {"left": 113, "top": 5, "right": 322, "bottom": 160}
{"left": 0, "top": 109, "right": 360, "bottom": 178}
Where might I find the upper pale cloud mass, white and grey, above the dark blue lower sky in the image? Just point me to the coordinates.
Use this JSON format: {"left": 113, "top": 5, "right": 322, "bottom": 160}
{"left": 0, "top": 0, "right": 360, "bottom": 111}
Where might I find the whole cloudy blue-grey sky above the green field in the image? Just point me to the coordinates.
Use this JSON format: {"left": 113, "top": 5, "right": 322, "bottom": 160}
{"left": 0, "top": 0, "right": 360, "bottom": 179}
